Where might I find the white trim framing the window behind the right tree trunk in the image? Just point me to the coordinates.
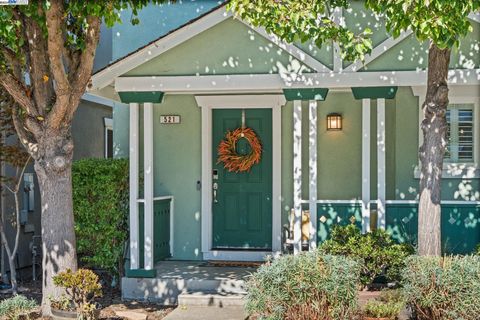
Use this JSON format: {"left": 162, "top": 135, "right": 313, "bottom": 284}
{"left": 412, "top": 85, "right": 480, "bottom": 179}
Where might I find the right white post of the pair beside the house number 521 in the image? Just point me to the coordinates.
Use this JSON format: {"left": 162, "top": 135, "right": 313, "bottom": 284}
{"left": 143, "top": 102, "right": 154, "bottom": 270}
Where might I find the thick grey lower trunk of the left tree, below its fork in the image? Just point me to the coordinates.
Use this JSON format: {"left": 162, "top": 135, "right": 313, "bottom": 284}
{"left": 35, "top": 129, "right": 77, "bottom": 315}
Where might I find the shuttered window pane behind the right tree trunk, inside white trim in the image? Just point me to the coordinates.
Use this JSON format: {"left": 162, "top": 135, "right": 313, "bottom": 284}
{"left": 445, "top": 104, "right": 475, "bottom": 163}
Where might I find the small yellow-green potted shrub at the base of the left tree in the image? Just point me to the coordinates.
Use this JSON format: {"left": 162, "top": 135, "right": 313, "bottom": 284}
{"left": 50, "top": 269, "right": 102, "bottom": 320}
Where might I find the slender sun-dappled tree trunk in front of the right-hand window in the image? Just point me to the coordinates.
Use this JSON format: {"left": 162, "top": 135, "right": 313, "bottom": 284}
{"left": 418, "top": 43, "right": 450, "bottom": 256}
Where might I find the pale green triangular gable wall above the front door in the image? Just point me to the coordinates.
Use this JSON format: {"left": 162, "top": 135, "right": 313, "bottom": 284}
{"left": 125, "top": 19, "right": 310, "bottom": 76}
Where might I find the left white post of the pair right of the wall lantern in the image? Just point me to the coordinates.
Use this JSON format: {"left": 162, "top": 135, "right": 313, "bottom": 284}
{"left": 362, "top": 99, "right": 370, "bottom": 233}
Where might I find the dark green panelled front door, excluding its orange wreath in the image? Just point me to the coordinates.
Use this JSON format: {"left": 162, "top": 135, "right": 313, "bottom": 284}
{"left": 212, "top": 109, "right": 272, "bottom": 250}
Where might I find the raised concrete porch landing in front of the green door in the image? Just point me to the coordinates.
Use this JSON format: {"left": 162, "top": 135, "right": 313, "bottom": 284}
{"left": 122, "top": 261, "right": 256, "bottom": 305}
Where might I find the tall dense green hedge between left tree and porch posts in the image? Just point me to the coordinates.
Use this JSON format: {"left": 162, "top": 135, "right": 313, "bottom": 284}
{"left": 72, "top": 159, "right": 128, "bottom": 274}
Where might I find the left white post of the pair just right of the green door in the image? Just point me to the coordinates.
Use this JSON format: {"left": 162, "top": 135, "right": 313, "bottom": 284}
{"left": 293, "top": 100, "right": 302, "bottom": 254}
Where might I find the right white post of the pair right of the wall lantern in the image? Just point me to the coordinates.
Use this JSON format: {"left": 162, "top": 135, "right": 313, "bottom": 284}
{"left": 377, "top": 98, "right": 386, "bottom": 229}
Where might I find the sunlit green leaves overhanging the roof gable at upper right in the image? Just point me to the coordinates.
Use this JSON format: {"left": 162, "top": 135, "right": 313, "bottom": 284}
{"left": 227, "top": 0, "right": 480, "bottom": 61}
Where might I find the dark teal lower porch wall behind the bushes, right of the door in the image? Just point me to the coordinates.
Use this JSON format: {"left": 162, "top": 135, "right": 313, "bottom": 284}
{"left": 308, "top": 200, "right": 480, "bottom": 254}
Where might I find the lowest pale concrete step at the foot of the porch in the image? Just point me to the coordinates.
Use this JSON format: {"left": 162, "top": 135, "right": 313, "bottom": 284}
{"left": 178, "top": 292, "right": 245, "bottom": 308}
